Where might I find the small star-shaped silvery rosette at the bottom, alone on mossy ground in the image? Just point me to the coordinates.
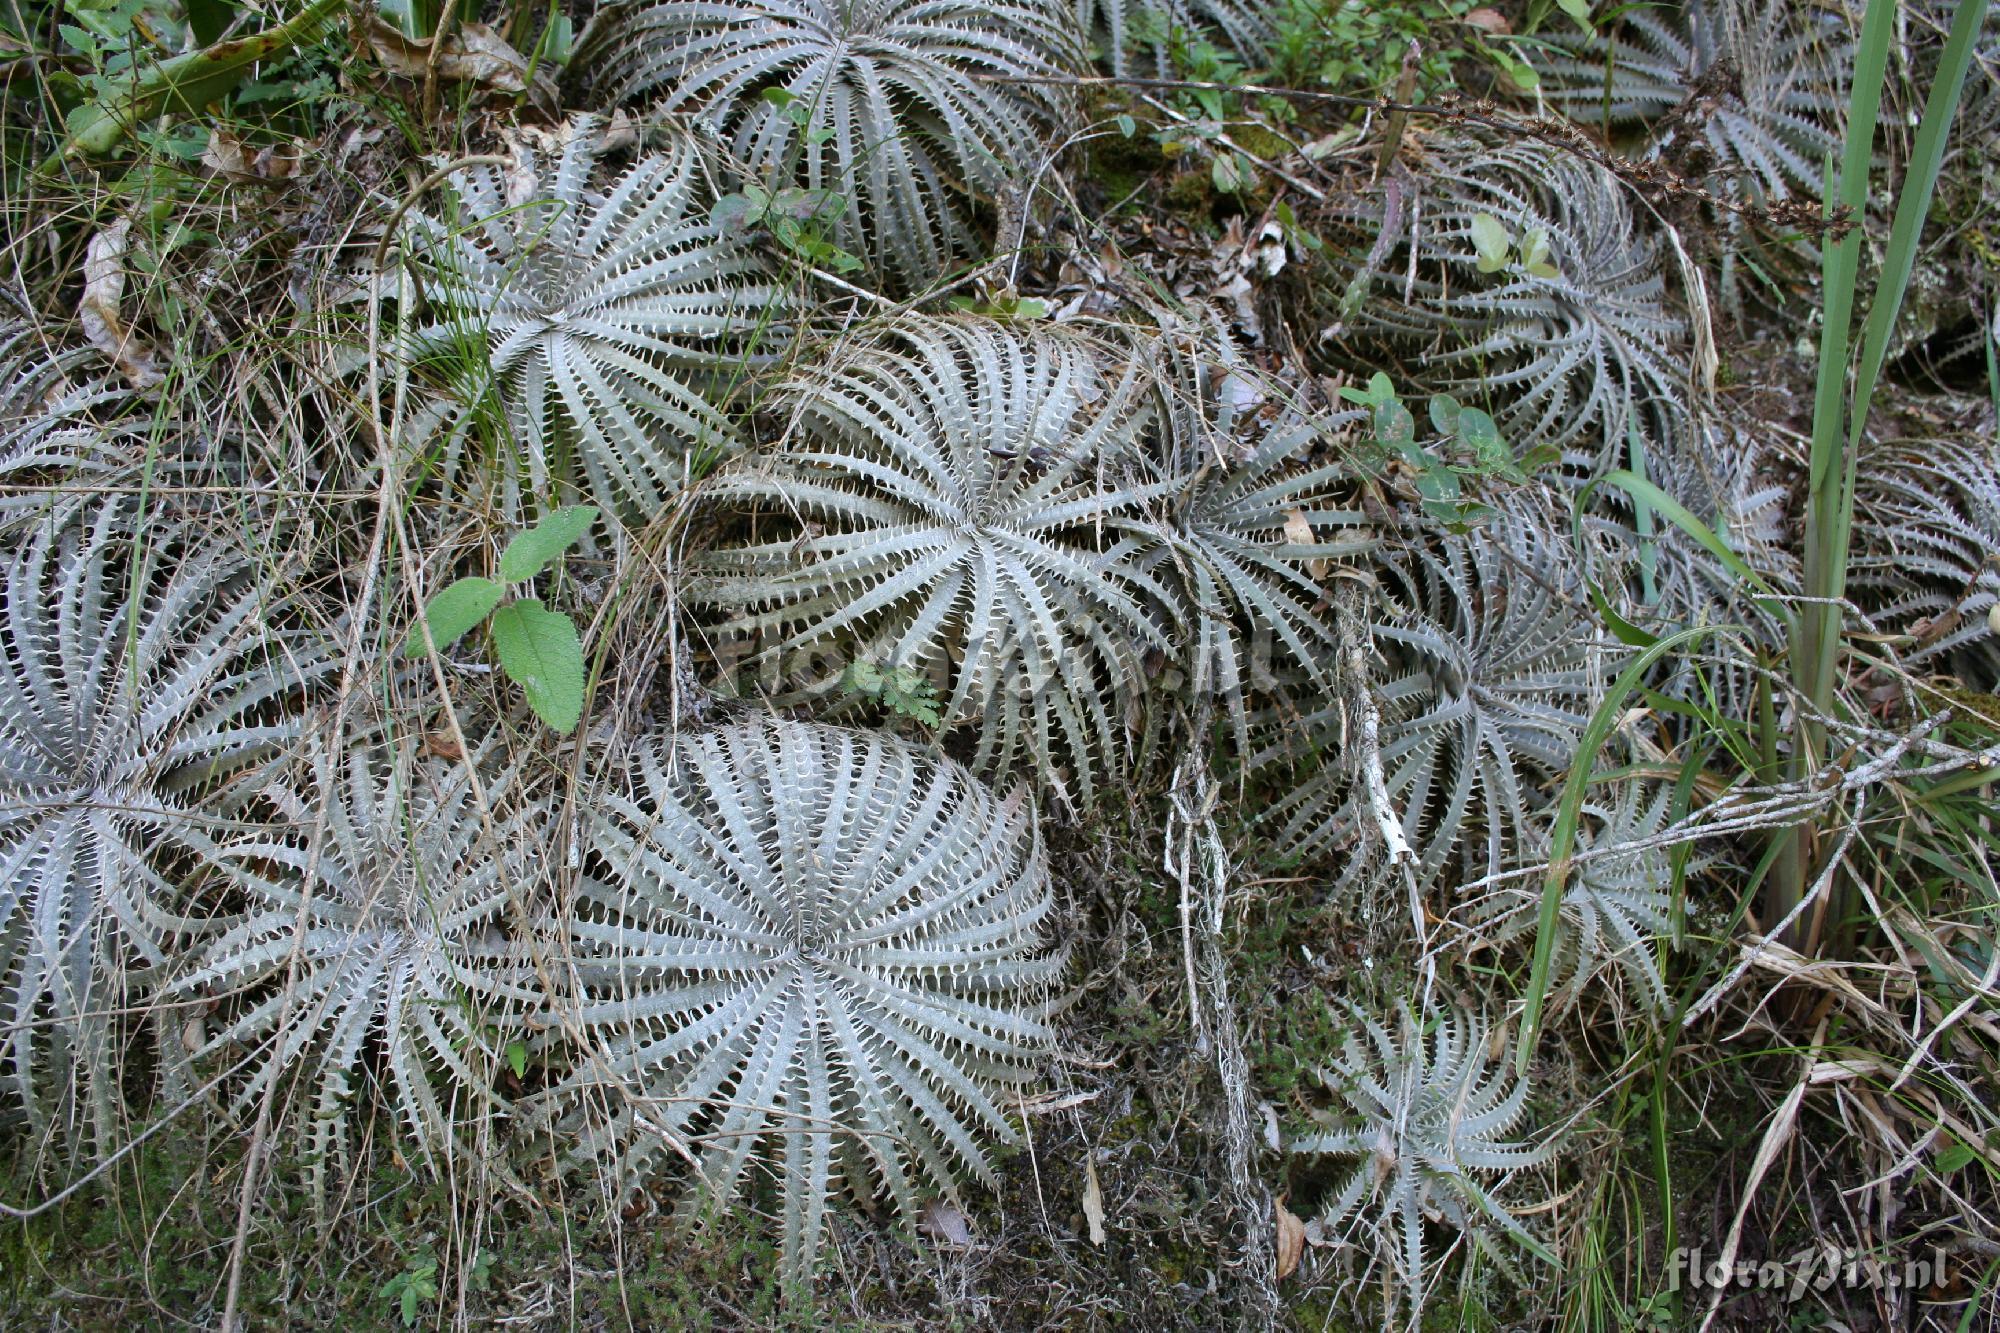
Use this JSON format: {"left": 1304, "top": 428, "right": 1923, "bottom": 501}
{"left": 1290, "top": 1007, "right": 1554, "bottom": 1303}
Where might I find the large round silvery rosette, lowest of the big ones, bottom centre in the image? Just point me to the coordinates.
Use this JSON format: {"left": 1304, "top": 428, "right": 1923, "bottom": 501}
{"left": 562, "top": 719, "right": 1062, "bottom": 1283}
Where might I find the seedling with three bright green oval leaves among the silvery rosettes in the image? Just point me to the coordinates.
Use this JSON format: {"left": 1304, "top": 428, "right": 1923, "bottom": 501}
{"left": 402, "top": 504, "right": 598, "bottom": 735}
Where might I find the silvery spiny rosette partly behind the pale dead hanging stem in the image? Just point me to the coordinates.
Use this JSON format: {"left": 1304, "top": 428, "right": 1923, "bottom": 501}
{"left": 1270, "top": 502, "right": 1612, "bottom": 879}
